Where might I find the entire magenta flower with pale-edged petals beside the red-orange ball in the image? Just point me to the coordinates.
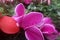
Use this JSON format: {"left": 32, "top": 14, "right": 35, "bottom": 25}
{"left": 13, "top": 3, "right": 57, "bottom": 40}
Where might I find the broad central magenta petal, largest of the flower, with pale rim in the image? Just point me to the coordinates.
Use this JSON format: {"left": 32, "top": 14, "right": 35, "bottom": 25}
{"left": 22, "top": 12, "right": 43, "bottom": 28}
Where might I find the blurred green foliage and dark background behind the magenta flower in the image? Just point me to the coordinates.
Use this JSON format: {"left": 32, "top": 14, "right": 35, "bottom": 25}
{"left": 0, "top": 0, "right": 60, "bottom": 40}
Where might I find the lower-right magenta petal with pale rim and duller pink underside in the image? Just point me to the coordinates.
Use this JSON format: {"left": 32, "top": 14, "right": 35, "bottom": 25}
{"left": 41, "top": 24, "right": 58, "bottom": 40}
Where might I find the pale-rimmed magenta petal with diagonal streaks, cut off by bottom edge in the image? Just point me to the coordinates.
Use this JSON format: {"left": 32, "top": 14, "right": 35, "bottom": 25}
{"left": 25, "top": 26, "right": 44, "bottom": 40}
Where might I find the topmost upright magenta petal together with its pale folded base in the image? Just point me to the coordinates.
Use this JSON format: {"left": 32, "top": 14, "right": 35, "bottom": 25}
{"left": 12, "top": 3, "right": 25, "bottom": 22}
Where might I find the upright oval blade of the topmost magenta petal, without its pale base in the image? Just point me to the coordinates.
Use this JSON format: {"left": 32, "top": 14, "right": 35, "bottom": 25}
{"left": 15, "top": 3, "right": 25, "bottom": 16}
